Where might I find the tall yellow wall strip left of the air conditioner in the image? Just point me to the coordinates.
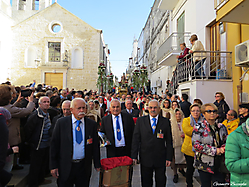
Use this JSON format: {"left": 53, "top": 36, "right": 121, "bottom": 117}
{"left": 226, "top": 23, "right": 241, "bottom": 110}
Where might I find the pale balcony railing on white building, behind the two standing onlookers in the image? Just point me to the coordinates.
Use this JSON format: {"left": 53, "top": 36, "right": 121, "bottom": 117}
{"left": 157, "top": 32, "right": 191, "bottom": 65}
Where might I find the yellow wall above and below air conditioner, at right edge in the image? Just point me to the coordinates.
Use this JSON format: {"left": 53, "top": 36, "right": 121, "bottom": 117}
{"left": 241, "top": 24, "right": 249, "bottom": 101}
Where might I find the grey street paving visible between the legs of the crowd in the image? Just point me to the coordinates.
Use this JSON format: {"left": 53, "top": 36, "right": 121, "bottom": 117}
{"left": 41, "top": 148, "right": 201, "bottom": 187}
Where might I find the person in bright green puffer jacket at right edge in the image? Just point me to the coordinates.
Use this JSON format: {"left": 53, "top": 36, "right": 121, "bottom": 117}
{"left": 225, "top": 119, "right": 249, "bottom": 187}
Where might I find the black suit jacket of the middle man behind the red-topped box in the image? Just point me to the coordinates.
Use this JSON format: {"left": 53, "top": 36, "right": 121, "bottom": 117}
{"left": 101, "top": 113, "right": 134, "bottom": 158}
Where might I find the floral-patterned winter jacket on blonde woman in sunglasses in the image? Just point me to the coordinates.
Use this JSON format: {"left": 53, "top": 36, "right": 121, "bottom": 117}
{"left": 192, "top": 119, "right": 227, "bottom": 174}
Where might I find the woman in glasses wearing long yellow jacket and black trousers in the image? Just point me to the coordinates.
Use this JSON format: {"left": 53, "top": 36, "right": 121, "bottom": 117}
{"left": 181, "top": 104, "right": 202, "bottom": 187}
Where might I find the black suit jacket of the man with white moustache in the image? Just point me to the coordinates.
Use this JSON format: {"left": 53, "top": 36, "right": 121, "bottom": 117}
{"left": 50, "top": 116, "right": 100, "bottom": 180}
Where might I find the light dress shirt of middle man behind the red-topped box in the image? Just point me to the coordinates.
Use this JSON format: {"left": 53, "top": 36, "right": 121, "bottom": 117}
{"left": 112, "top": 114, "right": 125, "bottom": 147}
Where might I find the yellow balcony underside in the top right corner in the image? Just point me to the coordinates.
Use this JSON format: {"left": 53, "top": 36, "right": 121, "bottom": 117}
{"left": 216, "top": 0, "right": 249, "bottom": 24}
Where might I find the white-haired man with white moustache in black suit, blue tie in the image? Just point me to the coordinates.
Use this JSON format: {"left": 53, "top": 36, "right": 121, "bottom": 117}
{"left": 50, "top": 98, "right": 100, "bottom": 187}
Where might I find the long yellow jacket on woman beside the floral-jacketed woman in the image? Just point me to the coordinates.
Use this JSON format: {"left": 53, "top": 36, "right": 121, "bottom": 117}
{"left": 181, "top": 117, "right": 195, "bottom": 157}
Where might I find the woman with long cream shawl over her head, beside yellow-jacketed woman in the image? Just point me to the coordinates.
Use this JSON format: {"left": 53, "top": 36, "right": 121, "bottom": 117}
{"left": 170, "top": 108, "right": 186, "bottom": 183}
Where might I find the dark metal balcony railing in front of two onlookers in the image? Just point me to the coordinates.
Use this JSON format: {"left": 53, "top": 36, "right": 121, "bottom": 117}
{"left": 170, "top": 51, "right": 232, "bottom": 93}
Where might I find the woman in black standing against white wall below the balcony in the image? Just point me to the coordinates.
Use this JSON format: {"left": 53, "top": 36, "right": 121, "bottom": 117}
{"left": 214, "top": 92, "right": 230, "bottom": 123}
